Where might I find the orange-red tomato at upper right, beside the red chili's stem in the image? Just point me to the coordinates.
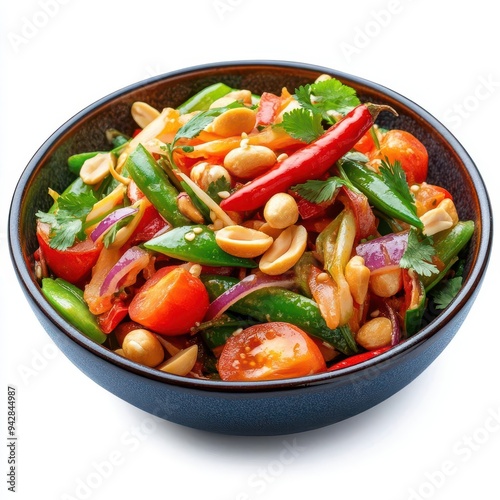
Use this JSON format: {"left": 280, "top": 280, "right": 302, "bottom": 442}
{"left": 369, "top": 129, "right": 429, "bottom": 186}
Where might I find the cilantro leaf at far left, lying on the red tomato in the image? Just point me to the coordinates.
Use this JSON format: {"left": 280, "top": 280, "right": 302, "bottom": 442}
{"left": 36, "top": 190, "right": 97, "bottom": 250}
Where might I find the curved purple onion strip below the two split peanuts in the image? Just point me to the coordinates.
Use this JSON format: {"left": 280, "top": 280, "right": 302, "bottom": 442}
{"left": 204, "top": 273, "right": 295, "bottom": 321}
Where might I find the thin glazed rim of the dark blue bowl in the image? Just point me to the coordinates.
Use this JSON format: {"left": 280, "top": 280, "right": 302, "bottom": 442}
{"left": 8, "top": 59, "right": 493, "bottom": 393}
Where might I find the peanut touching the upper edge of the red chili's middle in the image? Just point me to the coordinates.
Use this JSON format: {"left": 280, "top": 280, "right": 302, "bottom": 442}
{"left": 224, "top": 141, "right": 276, "bottom": 179}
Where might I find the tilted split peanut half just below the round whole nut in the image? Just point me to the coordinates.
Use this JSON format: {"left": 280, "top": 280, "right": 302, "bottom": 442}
{"left": 259, "top": 226, "right": 307, "bottom": 276}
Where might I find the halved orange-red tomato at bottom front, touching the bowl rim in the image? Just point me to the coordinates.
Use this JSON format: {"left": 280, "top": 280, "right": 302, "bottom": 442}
{"left": 218, "top": 322, "right": 326, "bottom": 381}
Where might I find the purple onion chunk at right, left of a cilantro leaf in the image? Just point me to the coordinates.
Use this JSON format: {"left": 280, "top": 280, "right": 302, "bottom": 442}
{"left": 356, "top": 231, "right": 408, "bottom": 271}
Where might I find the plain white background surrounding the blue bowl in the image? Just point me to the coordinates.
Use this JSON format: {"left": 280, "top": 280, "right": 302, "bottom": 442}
{"left": 0, "top": 0, "right": 500, "bottom": 500}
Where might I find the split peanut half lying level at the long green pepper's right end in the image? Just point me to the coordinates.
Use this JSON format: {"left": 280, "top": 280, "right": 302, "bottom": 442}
{"left": 215, "top": 225, "right": 273, "bottom": 259}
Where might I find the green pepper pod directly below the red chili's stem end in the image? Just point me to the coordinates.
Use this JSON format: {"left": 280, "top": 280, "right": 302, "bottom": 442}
{"left": 341, "top": 160, "right": 424, "bottom": 229}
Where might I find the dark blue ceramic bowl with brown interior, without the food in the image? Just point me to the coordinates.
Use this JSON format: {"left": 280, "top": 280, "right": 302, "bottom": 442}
{"left": 8, "top": 61, "right": 492, "bottom": 435}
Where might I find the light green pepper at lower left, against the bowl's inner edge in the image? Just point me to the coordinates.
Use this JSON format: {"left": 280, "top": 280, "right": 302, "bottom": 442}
{"left": 42, "top": 278, "right": 107, "bottom": 344}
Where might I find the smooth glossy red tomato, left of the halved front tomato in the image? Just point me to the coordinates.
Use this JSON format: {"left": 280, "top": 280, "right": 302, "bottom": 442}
{"left": 129, "top": 266, "right": 209, "bottom": 335}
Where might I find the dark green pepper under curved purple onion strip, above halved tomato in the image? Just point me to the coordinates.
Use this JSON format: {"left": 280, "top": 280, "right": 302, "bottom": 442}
{"left": 201, "top": 275, "right": 358, "bottom": 355}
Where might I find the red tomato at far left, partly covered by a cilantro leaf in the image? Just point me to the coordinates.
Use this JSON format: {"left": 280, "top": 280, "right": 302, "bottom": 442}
{"left": 36, "top": 222, "right": 102, "bottom": 285}
